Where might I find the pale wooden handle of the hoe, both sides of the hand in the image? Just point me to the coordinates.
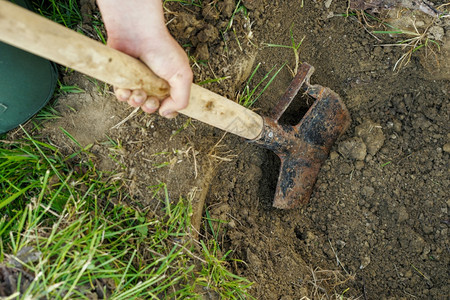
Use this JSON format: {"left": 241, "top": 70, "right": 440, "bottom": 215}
{"left": 0, "top": 0, "right": 263, "bottom": 139}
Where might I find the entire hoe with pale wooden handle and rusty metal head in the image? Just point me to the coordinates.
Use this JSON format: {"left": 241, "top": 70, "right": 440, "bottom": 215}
{"left": 0, "top": 0, "right": 350, "bottom": 209}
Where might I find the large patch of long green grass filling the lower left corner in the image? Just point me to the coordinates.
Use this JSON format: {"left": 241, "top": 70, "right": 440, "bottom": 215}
{"left": 0, "top": 132, "right": 250, "bottom": 299}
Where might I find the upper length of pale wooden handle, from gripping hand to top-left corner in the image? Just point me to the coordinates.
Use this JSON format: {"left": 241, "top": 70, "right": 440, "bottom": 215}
{"left": 0, "top": 0, "right": 169, "bottom": 97}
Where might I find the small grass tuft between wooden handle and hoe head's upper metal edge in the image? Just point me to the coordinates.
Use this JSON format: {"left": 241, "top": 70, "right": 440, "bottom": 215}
{"left": 238, "top": 63, "right": 284, "bottom": 108}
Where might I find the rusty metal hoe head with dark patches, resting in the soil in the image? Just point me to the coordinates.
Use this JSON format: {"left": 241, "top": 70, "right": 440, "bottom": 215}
{"left": 253, "top": 63, "right": 350, "bottom": 209}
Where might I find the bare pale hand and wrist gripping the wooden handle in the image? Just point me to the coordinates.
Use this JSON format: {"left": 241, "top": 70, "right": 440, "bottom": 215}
{"left": 97, "top": 0, "right": 193, "bottom": 118}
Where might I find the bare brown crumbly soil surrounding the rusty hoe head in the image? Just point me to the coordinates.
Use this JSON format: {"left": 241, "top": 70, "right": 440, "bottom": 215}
{"left": 9, "top": 0, "right": 450, "bottom": 300}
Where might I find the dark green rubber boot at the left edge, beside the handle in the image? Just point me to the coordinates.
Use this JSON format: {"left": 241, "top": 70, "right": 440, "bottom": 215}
{"left": 0, "top": 0, "right": 58, "bottom": 134}
